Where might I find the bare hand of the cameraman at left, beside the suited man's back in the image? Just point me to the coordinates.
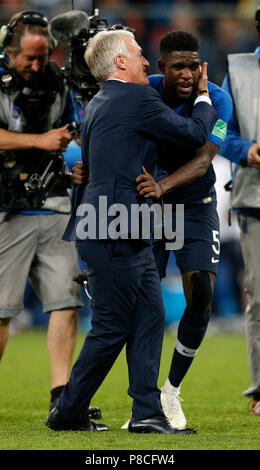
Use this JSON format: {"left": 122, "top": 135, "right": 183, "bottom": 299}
{"left": 36, "top": 124, "right": 73, "bottom": 152}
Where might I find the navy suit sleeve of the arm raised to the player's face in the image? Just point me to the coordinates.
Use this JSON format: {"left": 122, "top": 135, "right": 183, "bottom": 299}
{"left": 138, "top": 87, "right": 218, "bottom": 147}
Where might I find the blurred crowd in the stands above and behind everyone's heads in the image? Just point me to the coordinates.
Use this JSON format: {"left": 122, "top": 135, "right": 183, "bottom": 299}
{"left": 0, "top": 0, "right": 260, "bottom": 85}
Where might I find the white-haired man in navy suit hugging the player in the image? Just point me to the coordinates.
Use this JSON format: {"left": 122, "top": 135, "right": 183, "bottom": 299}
{"left": 46, "top": 30, "right": 217, "bottom": 434}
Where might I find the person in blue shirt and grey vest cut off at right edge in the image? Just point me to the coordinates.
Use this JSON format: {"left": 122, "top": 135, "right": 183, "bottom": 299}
{"left": 222, "top": 7, "right": 260, "bottom": 416}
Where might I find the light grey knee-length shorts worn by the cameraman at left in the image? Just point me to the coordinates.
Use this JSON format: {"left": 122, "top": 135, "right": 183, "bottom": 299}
{"left": 0, "top": 212, "right": 83, "bottom": 318}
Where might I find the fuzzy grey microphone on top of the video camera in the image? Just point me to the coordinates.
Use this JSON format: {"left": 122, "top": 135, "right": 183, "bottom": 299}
{"left": 48, "top": 10, "right": 90, "bottom": 42}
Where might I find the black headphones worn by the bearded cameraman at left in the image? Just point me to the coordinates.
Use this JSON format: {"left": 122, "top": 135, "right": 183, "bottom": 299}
{"left": 1, "top": 10, "right": 49, "bottom": 48}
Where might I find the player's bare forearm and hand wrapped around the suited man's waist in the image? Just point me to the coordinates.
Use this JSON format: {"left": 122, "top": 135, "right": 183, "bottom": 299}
{"left": 136, "top": 141, "right": 218, "bottom": 199}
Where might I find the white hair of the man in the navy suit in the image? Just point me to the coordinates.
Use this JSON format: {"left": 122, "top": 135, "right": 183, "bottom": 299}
{"left": 84, "top": 29, "right": 135, "bottom": 82}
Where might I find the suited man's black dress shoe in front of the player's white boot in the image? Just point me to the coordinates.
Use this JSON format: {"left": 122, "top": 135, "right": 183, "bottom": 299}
{"left": 128, "top": 416, "right": 196, "bottom": 434}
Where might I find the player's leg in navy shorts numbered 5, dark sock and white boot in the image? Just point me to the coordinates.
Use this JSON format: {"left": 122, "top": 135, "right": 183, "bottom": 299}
{"left": 161, "top": 200, "right": 220, "bottom": 428}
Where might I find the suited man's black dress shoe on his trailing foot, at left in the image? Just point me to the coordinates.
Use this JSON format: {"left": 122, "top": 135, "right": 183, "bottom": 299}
{"left": 46, "top": 407, "right": 108, "bottom": 431}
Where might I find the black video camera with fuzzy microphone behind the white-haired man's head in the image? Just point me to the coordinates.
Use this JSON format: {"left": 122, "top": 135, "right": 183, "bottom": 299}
{"left": 49, "top": 2, "right": 135, "bottom": 102}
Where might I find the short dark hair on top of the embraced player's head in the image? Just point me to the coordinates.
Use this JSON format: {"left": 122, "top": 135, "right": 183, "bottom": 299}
{"left": 160, "top": 31, "right": 199, "bottom": 54}
